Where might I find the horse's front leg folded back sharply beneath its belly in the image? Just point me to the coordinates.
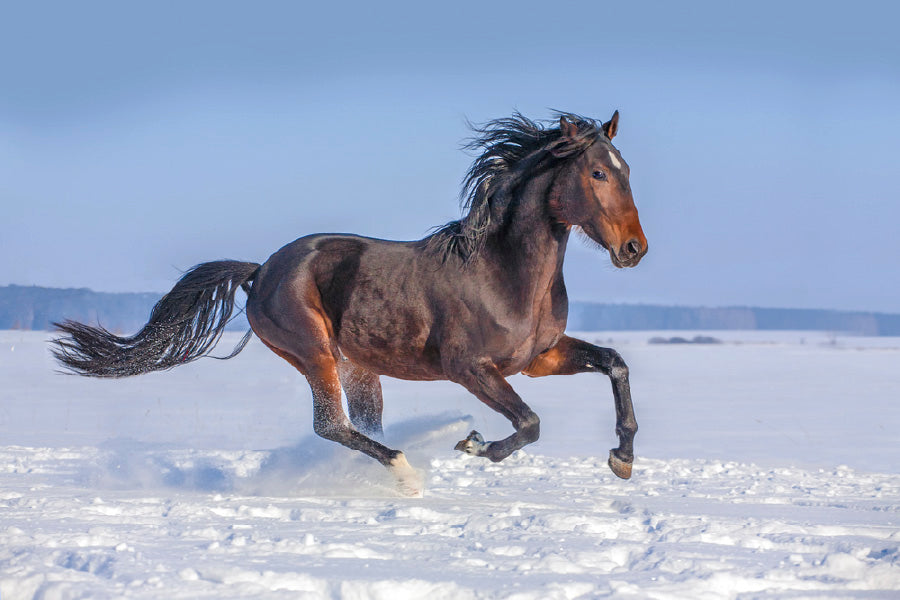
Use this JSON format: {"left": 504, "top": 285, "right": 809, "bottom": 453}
{"left": 445, "top": 360, "right": 541, "bottom": 462}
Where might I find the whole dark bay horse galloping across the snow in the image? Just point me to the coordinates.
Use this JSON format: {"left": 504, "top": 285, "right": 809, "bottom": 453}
{"left": 52, "top": 111, "right": 647, "bottom": 495}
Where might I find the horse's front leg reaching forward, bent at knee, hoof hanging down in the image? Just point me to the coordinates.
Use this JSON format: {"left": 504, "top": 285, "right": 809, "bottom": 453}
{"left": 522, "top": 336, "right": 637, "bottom": 479}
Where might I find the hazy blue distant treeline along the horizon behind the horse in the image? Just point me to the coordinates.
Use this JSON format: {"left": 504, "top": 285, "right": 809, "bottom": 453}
{"left": 0, "top": 285, "right": 900, "bottom": 335}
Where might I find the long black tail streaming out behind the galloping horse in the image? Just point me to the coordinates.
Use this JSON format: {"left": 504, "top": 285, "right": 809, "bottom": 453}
{"left": 52, "top": 260, "right": 259, "bottom": 377}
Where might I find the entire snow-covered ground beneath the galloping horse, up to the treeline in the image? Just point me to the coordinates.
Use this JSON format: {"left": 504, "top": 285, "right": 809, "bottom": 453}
{"left": 0, "top": 331, "right": 900, "bottom": 600}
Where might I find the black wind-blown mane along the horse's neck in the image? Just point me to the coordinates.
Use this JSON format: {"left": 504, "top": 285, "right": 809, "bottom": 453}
{"left": 424, "top": 112, "right": 604, "bottom": 264}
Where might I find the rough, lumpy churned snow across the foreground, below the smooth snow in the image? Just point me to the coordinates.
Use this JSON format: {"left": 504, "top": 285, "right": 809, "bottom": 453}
{"left": 0, "top": 442, "right": 900, "bottom": 599}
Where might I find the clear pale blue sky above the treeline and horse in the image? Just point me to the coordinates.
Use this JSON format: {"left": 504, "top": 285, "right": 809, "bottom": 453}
{"left": 0, "top": 2, "right": 900, "bottom": 312}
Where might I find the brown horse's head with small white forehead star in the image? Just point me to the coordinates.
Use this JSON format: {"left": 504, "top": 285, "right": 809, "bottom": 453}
{"left": 552, "top": 111, "right": 647, "bottom": 268}
